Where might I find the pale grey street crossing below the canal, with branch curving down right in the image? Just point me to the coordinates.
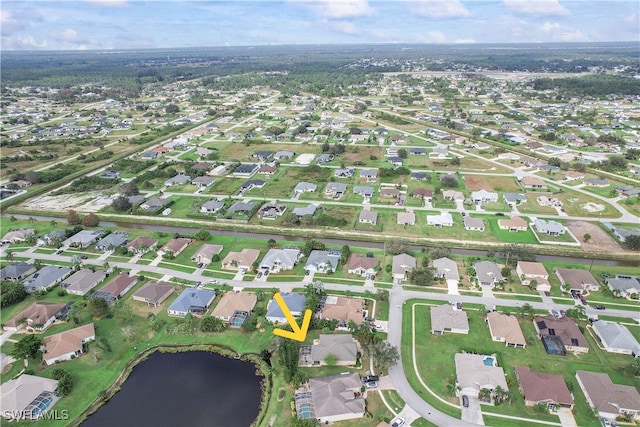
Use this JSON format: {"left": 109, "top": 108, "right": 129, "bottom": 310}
{"left": 10, "top": 252, "right": 640, "bottom": 426}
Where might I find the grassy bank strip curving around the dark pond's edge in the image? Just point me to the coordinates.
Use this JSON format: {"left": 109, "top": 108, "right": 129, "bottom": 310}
{"left": 69, "top": 343, "right": 273, "bottom": 427}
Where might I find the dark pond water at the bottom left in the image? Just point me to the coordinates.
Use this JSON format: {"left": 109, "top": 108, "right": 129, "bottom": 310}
{"left": 82, "top": 351, "right": 262, "bottom": 427}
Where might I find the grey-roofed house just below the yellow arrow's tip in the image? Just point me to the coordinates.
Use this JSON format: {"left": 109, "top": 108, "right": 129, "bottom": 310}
{"left": 299, "top": 334, "right": 358, "bottom": 366}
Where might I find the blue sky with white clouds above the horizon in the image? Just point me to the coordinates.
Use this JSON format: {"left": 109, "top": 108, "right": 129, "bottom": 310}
{"left": 0, "top": 0, "right": 640, "bottom": 50}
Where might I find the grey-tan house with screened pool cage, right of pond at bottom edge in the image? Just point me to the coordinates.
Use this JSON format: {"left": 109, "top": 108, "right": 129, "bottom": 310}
{"left": 294, "top": 372, "right": 365, "bottom": 424}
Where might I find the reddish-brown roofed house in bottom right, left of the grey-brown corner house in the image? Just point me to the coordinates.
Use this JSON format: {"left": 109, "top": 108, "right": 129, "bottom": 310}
{"left": 515, "top": 366, "right": 575, "bottom": 409}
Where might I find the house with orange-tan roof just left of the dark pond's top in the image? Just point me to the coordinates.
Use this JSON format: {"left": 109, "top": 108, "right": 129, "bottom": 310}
{"left": 42, "top": 323, "right": 96, "bottom": 365}
